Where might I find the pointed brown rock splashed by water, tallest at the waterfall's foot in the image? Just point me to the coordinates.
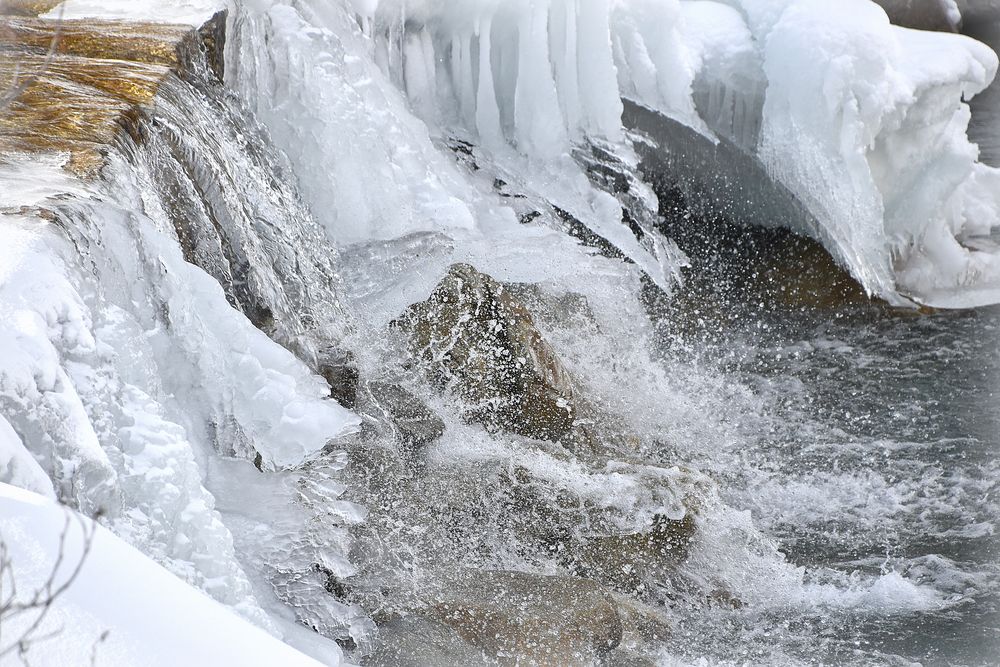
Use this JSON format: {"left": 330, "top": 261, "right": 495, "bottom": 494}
{"left": 395, "top": 264, "right": 577, "bottom": 441}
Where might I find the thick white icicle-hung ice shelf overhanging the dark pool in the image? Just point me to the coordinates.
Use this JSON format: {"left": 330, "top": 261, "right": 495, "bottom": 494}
{"left": 342, "top": 0, "right": 1000, "bottom": 308}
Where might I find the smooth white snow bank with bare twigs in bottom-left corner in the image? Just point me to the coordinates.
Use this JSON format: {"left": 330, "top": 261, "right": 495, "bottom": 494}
{"left": 0, "top": 484, "right": 326, "bottom": 667}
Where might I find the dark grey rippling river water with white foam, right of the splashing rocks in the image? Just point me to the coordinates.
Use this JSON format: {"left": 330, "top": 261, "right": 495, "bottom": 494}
{"left": 669, "top": 304, "right": 1000, "bottom": 665}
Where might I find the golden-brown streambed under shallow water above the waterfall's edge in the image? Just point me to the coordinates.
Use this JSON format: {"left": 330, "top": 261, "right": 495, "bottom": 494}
{"left": 0, "top": 17, "right": 196, "bottom": 176}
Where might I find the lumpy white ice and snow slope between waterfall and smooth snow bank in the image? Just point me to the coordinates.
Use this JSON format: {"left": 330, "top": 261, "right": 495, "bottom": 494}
{"left": 0, "top": 147, "right": 358, "bottom": 640}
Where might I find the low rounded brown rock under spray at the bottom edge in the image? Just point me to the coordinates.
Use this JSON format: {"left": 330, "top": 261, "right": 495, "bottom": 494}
{"left": 429, "top": 571, "right": 623, "bottom": 665}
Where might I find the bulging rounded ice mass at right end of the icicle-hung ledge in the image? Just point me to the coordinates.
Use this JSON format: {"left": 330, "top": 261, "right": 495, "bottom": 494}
{"left": 756, "top": 0, "right": 1000, "bottom": 306}
